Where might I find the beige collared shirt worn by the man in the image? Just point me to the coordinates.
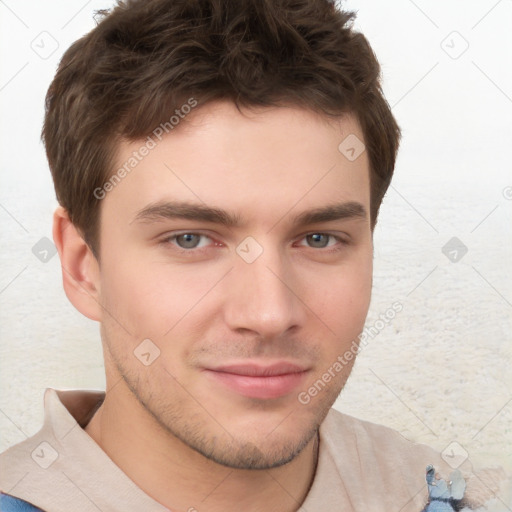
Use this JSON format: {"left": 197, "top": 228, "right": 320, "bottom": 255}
{"left": 0, "top": 388, "right": 512, "bottom": 512}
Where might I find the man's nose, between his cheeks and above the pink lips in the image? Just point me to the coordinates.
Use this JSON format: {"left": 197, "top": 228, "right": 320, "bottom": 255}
{"left": 224, "top": 243, "right": 306, "bottom": 339}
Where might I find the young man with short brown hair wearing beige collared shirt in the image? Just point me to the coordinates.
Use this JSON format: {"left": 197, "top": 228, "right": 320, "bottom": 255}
{"left": 0, "top": 0, "right": 506, "bottom": 512}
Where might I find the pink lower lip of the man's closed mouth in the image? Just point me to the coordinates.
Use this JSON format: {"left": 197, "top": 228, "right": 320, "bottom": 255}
{"left": 204, "top": 370, "right": 307, "bottom": 399}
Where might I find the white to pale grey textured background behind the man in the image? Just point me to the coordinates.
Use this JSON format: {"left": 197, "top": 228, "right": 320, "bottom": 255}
{"left": 0, "top": 0, "right": 512, "bottom": 476}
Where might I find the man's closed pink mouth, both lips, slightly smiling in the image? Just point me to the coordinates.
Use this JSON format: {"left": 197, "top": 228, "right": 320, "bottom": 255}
{"left": 203, "top": 362, "right": 309, "bottom": 400}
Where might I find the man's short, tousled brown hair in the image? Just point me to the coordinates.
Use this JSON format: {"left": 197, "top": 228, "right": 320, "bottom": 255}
{"left": 42, "top": 0, "right": 400, "bottom": 258}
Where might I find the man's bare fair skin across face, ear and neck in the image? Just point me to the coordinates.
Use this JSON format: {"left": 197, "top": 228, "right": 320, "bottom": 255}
{"left": 54, "top": 102, "right": 373, "bottom": 512}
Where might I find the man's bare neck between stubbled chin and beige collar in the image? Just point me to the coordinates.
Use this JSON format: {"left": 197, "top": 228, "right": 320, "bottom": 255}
{"left": 85, "top": 380, "right": 318, "bottom": 512}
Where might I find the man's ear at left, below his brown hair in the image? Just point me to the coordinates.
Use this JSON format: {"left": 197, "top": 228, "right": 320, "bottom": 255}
{"left": 53, "top": 206, "right": 102, "bottom": 322}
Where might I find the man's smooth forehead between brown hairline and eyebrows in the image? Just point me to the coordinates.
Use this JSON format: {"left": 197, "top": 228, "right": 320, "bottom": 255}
{"left": 102, "top": 102, "right": 369, "bottom": 232}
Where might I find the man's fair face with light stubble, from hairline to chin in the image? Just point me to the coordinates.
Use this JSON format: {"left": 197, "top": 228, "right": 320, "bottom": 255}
{"left": 94, "top": 102, "right": 372, "bottom": 469}
